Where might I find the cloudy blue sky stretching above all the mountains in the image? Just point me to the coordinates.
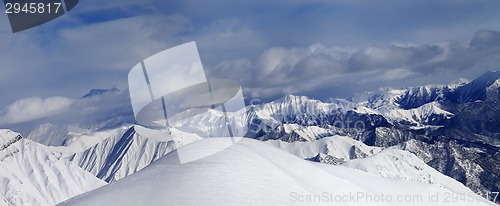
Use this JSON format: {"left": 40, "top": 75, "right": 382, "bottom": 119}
{"left": 0, "top": 0, "right": 500, "bottom": 126}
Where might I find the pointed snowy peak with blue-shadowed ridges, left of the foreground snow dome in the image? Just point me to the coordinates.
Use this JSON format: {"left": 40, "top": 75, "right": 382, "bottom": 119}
{"left": 65, "top": 127, "right": 201, "bottom": 182}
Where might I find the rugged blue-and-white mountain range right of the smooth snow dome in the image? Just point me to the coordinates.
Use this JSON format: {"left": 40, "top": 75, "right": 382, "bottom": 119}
{"left": 240, "top": 72, "right": 500, "bottom": 198}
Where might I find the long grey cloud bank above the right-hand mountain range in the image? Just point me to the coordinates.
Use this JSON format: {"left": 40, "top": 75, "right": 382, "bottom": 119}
{"left": 206, "top": 30, "right": 500, "bottom": 98}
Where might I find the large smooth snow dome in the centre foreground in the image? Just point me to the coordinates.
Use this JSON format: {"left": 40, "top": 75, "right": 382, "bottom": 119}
{"left": 61, "top": 138, "right": 494, "bottom": 206}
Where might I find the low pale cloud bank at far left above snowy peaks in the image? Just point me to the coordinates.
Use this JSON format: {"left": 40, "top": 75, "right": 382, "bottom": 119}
{"left": 0, "top": 88, "right": 135, "bottom": 135}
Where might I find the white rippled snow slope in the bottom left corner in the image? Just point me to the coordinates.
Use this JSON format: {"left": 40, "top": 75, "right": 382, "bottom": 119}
{"left": 0, "top": 130, "right": 106, "bottom": 206}
